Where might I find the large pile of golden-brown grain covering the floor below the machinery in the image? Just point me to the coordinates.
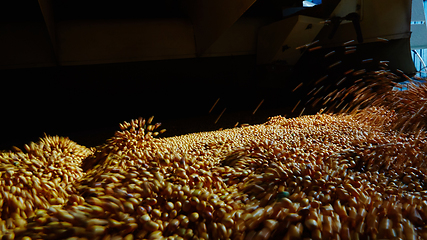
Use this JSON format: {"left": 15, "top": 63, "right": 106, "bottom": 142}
{"left": 0, "top": 107, "right": 427, "bottom": 240}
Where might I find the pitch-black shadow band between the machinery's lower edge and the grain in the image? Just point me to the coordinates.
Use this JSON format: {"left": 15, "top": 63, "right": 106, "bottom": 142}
{"left": 0, "top": 56, "right": 306, "bottom": 149}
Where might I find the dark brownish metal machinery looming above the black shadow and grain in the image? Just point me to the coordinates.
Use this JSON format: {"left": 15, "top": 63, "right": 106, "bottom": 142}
{"left": 0, "top": 0, "right": 425, "bottom": 73}
